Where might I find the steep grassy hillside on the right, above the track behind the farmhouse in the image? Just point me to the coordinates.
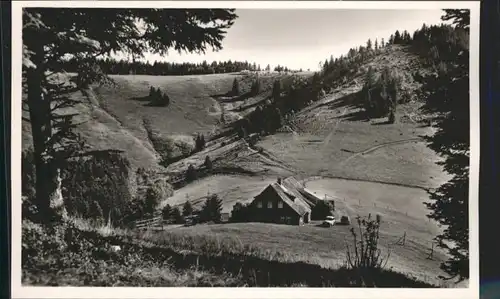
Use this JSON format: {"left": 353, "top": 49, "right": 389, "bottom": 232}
{"left": 259, "top": 47, "right": 449, "bottom": 188}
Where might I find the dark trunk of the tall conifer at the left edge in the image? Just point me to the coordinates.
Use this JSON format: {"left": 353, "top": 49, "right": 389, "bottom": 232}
{"left": 26, "top": 42, "right": 55, "bottom": 222}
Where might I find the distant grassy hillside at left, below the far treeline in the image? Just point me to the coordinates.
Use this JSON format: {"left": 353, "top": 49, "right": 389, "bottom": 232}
{"left": 22, "top": 74, "right": 286, "bottom": 172}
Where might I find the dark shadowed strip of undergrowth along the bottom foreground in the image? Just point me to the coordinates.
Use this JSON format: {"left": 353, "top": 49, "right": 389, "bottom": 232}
{"left": 22, "top": 221, "right": 433, "bottom": 288}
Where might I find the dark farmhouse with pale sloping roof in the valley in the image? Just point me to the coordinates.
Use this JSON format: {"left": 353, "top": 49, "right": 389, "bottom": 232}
{"left": 249, "top": 177, "right": 311, "bottom": 225}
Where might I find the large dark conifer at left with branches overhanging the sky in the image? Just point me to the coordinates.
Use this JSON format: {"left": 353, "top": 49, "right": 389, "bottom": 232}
{"left": 23, "top": 8, "right": 237, "bottom": 222}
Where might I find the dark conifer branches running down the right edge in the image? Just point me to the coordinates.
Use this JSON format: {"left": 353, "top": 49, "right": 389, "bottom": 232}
{"left": 424, "top": 10, "right": 470, "bottom": 279}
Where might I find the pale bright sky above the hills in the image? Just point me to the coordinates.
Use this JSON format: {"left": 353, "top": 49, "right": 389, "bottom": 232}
{"left": 139, "top": 9, "right": 443, "bottom": 71}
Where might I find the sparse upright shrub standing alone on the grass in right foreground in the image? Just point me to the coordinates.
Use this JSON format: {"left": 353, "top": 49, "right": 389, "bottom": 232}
{"left": 346, "top": 215, "right": 390, "bottom": 274}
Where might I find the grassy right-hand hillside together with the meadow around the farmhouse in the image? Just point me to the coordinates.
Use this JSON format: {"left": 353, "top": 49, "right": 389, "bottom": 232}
{"left": 153, "top": 48, "right": 460, "bottom": 286}
